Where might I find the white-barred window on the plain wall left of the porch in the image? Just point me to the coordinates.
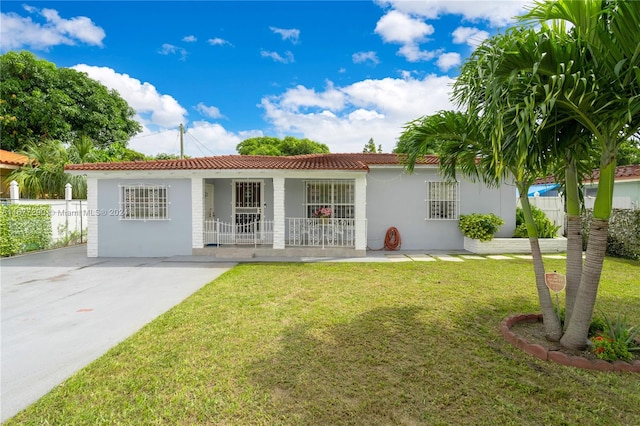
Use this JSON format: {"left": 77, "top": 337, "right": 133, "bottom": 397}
{"left": 119, "top": 184, "right": 169, "bottom": 220}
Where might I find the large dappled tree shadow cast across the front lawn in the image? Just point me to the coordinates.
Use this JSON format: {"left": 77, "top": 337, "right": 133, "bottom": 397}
{"left": 248, "top": 298, "right": 633, "bottom": 425}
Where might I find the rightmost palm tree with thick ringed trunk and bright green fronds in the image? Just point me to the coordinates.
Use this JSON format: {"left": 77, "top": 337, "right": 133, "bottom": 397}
{"left": 521, "top": 0, "right": 640, "bottom": 349}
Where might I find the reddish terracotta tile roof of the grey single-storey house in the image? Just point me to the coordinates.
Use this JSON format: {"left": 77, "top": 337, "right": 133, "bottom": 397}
{"left": 65, "top": 153, "right": 438, "bottom": 171}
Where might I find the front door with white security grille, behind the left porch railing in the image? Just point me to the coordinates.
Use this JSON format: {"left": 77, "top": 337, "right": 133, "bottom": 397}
{"left": 233, "top": 180, "right": 264, "bottom": 244}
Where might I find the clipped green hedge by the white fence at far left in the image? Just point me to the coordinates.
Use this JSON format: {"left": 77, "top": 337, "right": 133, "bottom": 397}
{"left": 0, "top": 204, "right": 51, "bottom": 256}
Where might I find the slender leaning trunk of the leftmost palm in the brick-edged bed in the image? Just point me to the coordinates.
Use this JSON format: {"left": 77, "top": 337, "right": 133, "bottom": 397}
{"left": 518, "top": 192, "right": 562, "bottom": 342}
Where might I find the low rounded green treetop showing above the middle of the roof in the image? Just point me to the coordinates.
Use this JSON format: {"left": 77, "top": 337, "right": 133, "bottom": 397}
{"left": 236, "top": 136, "right": 329, "bottom": 156}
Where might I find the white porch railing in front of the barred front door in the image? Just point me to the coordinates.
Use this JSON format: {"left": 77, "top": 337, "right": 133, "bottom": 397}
{"left": 204, "top": 219, "right": 273, "bottom": 246}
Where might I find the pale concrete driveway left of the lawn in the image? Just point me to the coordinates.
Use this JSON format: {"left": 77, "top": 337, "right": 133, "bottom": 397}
{"left": 0, "top": 246, "right": 234, "bottom": 422}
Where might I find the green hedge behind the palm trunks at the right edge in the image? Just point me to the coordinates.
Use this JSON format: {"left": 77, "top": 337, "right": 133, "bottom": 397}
{"left": 582, "top": 209, "right": 640, "bottom": 259}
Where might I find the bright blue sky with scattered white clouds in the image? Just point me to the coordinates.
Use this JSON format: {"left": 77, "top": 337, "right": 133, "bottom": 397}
{"left": 0, "top": 0, "right": 527, "bottom": 156}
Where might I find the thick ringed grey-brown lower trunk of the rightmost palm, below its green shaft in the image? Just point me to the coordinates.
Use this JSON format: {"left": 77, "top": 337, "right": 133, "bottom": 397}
{"left": 560, "top": 219, "right": 609, "bottom": 349}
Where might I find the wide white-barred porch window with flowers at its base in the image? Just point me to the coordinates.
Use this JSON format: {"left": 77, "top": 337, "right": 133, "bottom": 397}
{"left": 304, "top": 180, "right": 355, "bottom": 219}
